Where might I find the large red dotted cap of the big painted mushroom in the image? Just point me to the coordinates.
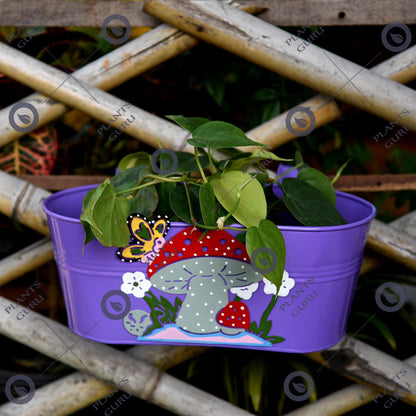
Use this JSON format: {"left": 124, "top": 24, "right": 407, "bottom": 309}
{"left": 147, "top": 225, "right": 250, "bottom": 278}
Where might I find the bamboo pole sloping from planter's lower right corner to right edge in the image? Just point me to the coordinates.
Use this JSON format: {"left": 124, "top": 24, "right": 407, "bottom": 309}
{"left": 305, "top": 335, "right": 416, "bottom": 406}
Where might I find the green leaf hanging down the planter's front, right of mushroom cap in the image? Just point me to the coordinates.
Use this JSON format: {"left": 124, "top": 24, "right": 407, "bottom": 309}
{"left": 246, "top": 220, "right": 286, "bottom": 293}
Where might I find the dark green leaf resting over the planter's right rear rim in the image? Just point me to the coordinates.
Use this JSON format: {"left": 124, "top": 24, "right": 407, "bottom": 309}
{"left": 282, "top": 178, "right": 347, "bottom": 227}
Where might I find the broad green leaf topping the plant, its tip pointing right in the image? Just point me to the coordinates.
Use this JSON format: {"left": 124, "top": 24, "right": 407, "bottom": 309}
{"left": 188, "top": 121, "right": 265, "bottom": 149}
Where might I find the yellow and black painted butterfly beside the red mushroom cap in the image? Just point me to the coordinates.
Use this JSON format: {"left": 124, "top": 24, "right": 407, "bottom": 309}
{"left": 117, "top": 214, "right": 170, "bottom": 264}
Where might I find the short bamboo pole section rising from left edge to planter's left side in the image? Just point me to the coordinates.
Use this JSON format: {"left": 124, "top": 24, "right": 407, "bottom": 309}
{"left": 0, "top": 238, "right": 53, "bottom": 286}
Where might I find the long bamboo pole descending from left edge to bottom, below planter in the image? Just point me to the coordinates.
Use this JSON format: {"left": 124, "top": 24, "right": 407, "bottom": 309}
{"left": 0, "top": 297, "right": 254, "bottom": 416}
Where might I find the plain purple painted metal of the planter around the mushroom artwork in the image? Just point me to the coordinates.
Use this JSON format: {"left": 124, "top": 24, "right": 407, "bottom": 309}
{"left": 44, "top": 186, "right": 376, "bottom": 353}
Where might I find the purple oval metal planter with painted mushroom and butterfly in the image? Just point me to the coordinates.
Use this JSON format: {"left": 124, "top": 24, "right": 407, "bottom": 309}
{"left": 43, "top": 186, "right": 376, "bottom": 353}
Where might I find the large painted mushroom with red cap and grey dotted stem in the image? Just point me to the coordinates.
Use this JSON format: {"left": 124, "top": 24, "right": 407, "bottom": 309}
{"left": 147, "top": 226, "right": 263, "bottom": 334}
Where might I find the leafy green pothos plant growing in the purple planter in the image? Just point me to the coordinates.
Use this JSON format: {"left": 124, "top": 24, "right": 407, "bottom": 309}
{"left": 80, "top": 116, "right": 345, "bottom": 288}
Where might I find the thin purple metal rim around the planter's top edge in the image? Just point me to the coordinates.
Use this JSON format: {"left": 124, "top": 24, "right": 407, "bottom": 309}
{"left": 42, "top": 184, "right": 377, "bottom": 232}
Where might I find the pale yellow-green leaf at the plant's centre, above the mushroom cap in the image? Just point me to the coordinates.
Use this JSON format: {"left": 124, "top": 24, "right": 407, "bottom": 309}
{"left": 209, "top": 170, "right": 267, "bottom": 228}
